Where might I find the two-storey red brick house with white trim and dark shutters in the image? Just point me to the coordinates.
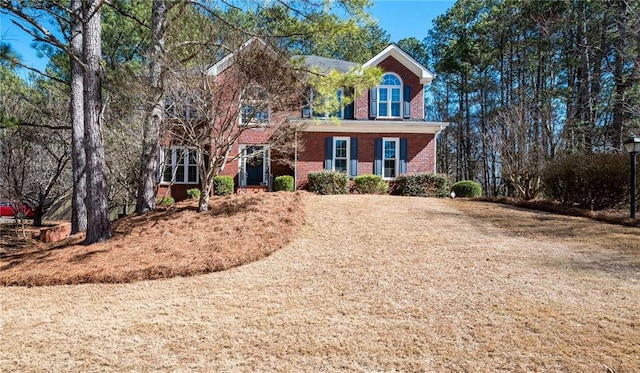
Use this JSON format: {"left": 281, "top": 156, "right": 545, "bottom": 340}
{"left": 159, "top": 39, "right": 448, "bottom": 199}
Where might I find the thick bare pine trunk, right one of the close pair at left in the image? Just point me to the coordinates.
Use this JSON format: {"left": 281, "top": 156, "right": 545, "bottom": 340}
{"left": 82, "top": 0, "right": 111, "bottom": 245}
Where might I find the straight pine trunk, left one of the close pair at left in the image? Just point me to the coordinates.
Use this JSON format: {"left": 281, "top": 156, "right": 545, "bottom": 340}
{"left": 69, "top": 0, "right": 87, "bottom": 234}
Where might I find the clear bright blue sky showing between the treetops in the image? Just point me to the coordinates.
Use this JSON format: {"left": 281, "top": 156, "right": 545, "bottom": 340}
{"left": 0, "top": 0, "right": 455, "bottom": 77}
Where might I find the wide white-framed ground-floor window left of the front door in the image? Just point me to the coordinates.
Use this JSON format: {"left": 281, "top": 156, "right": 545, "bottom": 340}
{"left": 160, "top": 147, "right": 199, "bottom": 184}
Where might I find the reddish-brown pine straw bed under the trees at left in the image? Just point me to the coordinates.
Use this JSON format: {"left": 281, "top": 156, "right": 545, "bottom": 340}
{"left": 0, "top": 192, "right": 303, "bottom": 286}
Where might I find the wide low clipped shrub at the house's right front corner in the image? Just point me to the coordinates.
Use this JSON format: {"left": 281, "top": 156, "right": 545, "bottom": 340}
{"left": 391, "top": 174, "right": 449, "bottom": 197}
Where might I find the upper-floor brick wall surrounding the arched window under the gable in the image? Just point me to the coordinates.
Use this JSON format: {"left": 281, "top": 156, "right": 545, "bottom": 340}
{"left": 355, "top": 56, "right": 424, "bottom": 120}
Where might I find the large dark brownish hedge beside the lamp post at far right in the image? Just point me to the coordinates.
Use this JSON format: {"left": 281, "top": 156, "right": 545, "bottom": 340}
{"left": 542, "top": 154, "right": 630, "bottom": 210}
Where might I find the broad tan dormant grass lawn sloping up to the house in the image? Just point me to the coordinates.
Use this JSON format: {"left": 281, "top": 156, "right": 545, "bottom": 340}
{"left": 0, "top": 196, "right": 640, "bottom": 372}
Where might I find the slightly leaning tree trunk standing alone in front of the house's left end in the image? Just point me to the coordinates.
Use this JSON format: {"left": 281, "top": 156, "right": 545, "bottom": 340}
{"left": 136, "top": 0, "right": 167, "bottom": 214}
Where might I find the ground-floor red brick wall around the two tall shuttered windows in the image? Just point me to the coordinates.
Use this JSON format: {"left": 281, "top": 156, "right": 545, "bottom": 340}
{"left": 296, "top": 132, "right": 436, "bottom": 188}
